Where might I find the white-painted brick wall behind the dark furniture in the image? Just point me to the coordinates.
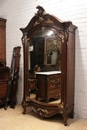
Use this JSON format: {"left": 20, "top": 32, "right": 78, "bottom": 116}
{"left": 0, "top": 0, "right": 87, "bottom": 118}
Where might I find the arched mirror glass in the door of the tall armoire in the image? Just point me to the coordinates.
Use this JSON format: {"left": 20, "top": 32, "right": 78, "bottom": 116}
{"left": 29, "top": 29, "right": 61, "bottom": 103}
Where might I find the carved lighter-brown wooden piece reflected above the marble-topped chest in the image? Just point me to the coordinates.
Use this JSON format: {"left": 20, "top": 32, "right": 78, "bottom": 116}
{"left": 44, "top": 36, "right": 61, "bottom": 70}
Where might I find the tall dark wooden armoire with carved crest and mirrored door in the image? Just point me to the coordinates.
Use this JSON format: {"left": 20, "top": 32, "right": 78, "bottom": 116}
{"left": 21, "top": 6, "right": 77, "bottom": 125}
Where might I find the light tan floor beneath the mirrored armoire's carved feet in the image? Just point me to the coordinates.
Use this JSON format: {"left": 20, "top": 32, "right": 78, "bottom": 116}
{"left": 0, "top": 105, "right": 87, "bottom": 130}
